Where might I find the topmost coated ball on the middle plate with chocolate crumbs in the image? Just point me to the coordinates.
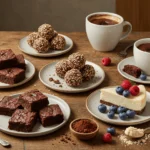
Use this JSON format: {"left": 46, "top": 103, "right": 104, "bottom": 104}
{"left": 68, "top": 53, "right": 86, "bottom": 70}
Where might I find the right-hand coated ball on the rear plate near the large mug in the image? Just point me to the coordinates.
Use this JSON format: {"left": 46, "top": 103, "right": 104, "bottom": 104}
{"left": 50, "top": 35, "right": 66, "bottom": 50}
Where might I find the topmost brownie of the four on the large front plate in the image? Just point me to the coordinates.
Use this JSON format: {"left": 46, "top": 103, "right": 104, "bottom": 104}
{"left": 19, "top": 89, "right": 49, "bottom": 111}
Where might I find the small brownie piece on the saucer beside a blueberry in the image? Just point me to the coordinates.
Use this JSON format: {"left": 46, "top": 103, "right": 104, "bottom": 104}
{"left": 123, "top": 65, "right": 142, "bottom": 78}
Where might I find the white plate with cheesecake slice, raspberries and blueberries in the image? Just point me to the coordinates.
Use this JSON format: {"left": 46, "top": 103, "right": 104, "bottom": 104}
{"left": 86, "top": 80, "right": 150, "bottom": 125}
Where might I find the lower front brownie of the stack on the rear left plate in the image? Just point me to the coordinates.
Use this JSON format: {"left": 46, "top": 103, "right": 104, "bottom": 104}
{"left": 0, "top": 68, "right": 25, "bottom": 84}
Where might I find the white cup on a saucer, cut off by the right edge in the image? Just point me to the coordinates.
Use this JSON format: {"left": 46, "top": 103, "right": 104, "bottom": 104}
{"left": 133, "top": 38, "right": 150, "bottom": 75}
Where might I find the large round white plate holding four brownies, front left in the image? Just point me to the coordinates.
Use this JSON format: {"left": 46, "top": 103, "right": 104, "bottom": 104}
{"left": 0, "top": 93, "right": 70, "bottom": 137}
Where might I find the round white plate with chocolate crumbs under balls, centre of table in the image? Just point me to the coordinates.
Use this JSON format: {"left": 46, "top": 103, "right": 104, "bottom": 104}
{"left": 39, "top": 61, "right": 105, "bottom": 93}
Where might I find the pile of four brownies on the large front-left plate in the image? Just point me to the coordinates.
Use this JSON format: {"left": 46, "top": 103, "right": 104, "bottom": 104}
{"left": 0, "top": 89, "right": 64, "bottom": 132}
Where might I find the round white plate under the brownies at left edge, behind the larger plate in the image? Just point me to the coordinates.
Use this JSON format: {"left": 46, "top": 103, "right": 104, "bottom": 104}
{"left": 0, "top": 59, "right": 35, "bottom": 89}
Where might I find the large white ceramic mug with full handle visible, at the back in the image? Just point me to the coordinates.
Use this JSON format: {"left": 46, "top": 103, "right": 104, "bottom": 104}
{"left": 86, "top": 12, "right": 132, "bottom": 51}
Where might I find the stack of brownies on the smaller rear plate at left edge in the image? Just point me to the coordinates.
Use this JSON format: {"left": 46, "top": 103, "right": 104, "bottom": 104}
{"left": 0, "top": 49, "right": 26, "bottom": 84}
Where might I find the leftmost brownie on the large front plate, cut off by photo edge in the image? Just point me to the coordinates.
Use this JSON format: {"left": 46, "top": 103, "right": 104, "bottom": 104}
{"left": 0, "top": 96, "right": 21, "bottom": 116}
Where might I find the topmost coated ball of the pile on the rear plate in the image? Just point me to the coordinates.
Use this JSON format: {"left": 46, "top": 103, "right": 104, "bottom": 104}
{"left": 38, "top": 24, "right": 54, "bottom": 40}
